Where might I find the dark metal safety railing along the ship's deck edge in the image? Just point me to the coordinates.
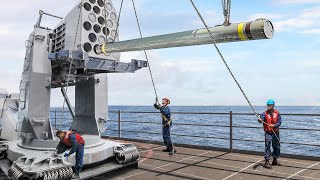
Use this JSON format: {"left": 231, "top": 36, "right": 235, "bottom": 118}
{"left": 50, "top": 110, "right": 320, "bottom": 152}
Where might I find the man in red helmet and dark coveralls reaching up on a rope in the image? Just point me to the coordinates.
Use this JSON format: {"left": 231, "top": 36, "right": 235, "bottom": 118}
{"left": 154, "top": 98, "right": 177, "bottom": 155}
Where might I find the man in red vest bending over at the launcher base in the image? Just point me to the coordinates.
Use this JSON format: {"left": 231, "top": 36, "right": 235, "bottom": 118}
{"left": 56, "top": 130, "right": 85, "bottom": 179}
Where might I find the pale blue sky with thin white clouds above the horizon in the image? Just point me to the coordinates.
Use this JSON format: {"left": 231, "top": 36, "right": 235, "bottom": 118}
{"left": 0, "top": 0, "right": 320, "bottom": 107}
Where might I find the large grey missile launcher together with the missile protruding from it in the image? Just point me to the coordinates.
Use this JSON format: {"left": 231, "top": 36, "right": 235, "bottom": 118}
{"left": 0, "top": 0, "right": 273, "bottom": 179}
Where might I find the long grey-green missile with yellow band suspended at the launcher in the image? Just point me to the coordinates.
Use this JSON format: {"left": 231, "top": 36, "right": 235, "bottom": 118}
{"left": 95, "top": 19, "right": 274, "bottom": 54}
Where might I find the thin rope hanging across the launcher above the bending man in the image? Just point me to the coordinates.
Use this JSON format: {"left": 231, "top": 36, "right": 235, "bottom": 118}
{"left": 59, "top": 3, "right": 82, "bottom": 129}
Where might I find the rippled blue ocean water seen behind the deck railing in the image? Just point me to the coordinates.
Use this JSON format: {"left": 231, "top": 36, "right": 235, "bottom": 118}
{"left": 51, "top": 106, "right": 320, "bottom": 156}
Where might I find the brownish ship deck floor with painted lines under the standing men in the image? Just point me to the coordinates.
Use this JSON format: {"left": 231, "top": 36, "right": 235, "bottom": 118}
{"left": 90, "top": 140, "right": 320, "bottom": 180}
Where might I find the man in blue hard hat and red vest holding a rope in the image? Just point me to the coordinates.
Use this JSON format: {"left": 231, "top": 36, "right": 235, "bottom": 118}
{"left": 258, "top": 99, "right": 281, "bottom": 169}
